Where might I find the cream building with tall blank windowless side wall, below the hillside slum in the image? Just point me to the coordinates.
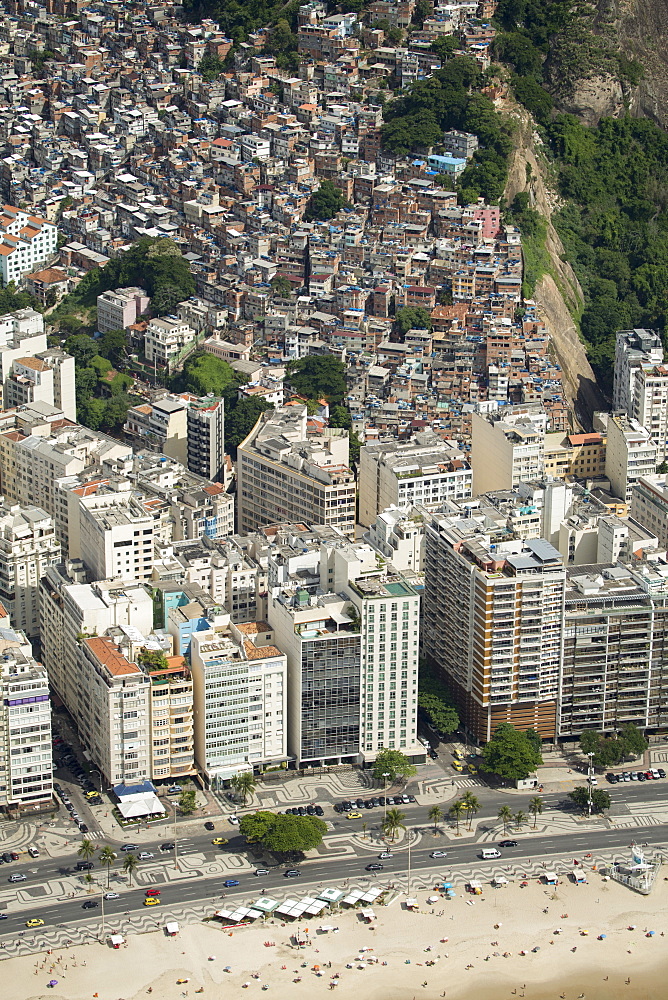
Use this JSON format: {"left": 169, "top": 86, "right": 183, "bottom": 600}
{"left": 471, "top": 408, "right": 547, "bottom": 496}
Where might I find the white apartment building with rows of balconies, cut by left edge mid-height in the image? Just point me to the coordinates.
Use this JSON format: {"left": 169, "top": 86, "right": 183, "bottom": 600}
{"left": 0, "top": 503, "right": 60, "bottom": 636}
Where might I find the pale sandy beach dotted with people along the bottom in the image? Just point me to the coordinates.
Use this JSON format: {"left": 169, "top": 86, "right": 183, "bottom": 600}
{"left": 7, "top": 872, "right": 668, "bottom": 1000}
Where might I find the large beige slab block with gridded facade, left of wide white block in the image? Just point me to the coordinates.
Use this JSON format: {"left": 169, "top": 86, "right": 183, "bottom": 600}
{"left": 237, "top": 406, "right": 355, "bottom": 537}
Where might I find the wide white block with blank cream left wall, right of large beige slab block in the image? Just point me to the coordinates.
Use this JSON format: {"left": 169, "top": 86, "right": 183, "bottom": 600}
{"left": 359, "top": 431, "right": 473, "bottom": 527}
